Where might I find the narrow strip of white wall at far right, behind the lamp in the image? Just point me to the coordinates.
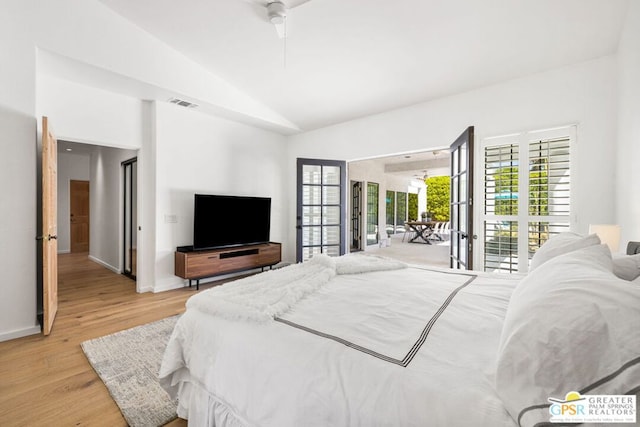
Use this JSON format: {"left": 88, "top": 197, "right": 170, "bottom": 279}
{"left": 615, "top": 1, "right": 640, "bottom": 247}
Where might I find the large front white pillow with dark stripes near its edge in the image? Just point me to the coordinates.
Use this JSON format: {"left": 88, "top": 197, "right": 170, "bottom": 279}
{"left": 496, "top": 245, "right": 640, "bottom": 426}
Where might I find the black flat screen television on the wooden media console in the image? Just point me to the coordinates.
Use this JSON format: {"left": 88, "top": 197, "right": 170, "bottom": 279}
{"left": 193, "top": 194, "right": 271, "bottom": 250}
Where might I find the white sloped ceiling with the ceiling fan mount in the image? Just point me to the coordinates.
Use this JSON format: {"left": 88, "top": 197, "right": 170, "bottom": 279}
{"left": 100, "top": 0, "right": 628, "bottom": 130}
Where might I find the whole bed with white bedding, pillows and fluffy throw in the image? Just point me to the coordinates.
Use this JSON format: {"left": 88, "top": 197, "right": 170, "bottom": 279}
{"left": 160, "top": 233, "right": 640, "bottom": 427}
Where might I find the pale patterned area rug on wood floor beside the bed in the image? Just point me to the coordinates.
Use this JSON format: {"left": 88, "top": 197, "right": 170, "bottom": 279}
{"left": 81, "top": 316, "right": 179, "bottom": 427}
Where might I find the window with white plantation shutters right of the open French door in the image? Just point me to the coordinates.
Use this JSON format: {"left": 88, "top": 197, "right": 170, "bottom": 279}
{"left": 481, "top": 127, "right": 575, "bottom": 272}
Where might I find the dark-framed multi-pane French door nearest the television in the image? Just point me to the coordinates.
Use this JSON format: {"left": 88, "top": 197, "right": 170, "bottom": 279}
{"left": 296, "top": 159, "right": 347, "bottom": 262}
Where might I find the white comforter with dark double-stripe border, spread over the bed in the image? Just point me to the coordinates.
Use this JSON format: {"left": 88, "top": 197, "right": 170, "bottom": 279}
{"left": 160, "top": 260, "right": 516, "bottom": 427}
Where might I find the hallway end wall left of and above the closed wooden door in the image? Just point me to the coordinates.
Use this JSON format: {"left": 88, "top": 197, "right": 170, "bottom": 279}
{"left": 58, "top": 152, "right": 90, "bottom": 253}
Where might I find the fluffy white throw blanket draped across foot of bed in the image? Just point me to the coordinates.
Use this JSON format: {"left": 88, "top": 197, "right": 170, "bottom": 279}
{"left": 187, "top": 254, "right": 407, "bottom": 322}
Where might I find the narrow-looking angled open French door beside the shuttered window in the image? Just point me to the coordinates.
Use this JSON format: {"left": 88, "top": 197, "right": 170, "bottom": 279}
{"left": 449, "top": 126, "right": 475, "bottom": 270}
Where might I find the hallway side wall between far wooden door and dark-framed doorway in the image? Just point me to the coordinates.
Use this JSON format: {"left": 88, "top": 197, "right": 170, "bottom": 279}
{"left": 89, "top": 147, "right": 137, "bottom": 273}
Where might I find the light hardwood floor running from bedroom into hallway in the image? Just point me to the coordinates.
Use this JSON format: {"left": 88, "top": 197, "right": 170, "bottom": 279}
{"left": 0, "top": 253, "right": 211, "bottom": 426}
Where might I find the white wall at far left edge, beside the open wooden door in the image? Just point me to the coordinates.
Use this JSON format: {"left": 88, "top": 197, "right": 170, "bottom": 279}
{"left": 0, "top": 1, "right": 40, "bottom": 341}
